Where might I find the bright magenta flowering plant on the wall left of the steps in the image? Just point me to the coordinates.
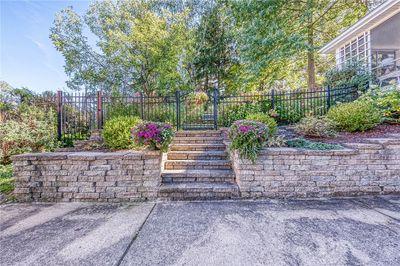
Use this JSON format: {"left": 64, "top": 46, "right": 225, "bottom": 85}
{"left": 132, "top": 122, "right": 174, "bottom": 151}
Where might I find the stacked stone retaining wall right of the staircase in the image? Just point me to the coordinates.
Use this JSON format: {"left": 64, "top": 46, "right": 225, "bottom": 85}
{"left": 231, "top": 137, "right": 400, "bottom": 197}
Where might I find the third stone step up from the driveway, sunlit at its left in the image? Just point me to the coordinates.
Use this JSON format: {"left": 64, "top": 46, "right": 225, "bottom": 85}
{"left": 164, "top": 160, "right": 232, "bottom": 170}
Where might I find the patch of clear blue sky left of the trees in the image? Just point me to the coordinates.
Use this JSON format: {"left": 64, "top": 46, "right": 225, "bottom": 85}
{"left": 0, "top": 0, "right": 90, "bottom": 92}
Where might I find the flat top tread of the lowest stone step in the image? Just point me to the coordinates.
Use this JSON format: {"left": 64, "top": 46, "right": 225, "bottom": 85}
{"left": 159, "top": 182, "right": 239, "bottom": 193}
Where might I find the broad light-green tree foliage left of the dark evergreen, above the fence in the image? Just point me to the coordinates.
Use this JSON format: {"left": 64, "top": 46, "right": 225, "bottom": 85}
{"left": 50, "top": 0, "right": 192, "bottom": 94}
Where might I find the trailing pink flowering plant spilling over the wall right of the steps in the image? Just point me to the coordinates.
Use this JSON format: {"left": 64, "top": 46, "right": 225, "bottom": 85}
{"left": 228, "top": 120, "right": 269, "bottom": 163}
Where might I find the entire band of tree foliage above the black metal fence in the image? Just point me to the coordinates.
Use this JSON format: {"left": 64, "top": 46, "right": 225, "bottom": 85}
{"left": 50, "top": 0, "right": 370, "bottom": 94}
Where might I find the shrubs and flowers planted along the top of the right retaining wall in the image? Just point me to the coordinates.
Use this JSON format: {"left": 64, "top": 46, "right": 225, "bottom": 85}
{"left": 229, "top": 86, "right": 400, "bottom": 161}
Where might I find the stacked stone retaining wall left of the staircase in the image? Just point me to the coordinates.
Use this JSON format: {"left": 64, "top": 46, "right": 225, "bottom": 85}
{"left": 12, "top": 151, "right": 162, "bottom": 202}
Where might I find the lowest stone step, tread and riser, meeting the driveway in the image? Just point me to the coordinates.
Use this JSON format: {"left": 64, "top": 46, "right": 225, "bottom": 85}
{"left": 158, "top": 182, "right": 239, "bottom": 200}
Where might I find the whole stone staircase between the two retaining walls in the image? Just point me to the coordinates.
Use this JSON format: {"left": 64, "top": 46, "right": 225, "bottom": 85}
{"left": 159, "top": 131, "right": 239, "bottom": 200}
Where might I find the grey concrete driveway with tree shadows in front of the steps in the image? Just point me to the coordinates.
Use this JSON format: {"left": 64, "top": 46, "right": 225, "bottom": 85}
{"left": 0, "top": 197, "right": 400, "bottom": 266}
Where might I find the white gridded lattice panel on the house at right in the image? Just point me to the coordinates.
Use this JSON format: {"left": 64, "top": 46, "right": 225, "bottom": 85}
{"left": 336, "top": 32, "right": 370, "bottom": 67}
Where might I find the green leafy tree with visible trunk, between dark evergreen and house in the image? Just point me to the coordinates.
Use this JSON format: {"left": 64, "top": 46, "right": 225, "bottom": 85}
{"left": 230, "top": 0, "right": 367, "bottom": 89}
